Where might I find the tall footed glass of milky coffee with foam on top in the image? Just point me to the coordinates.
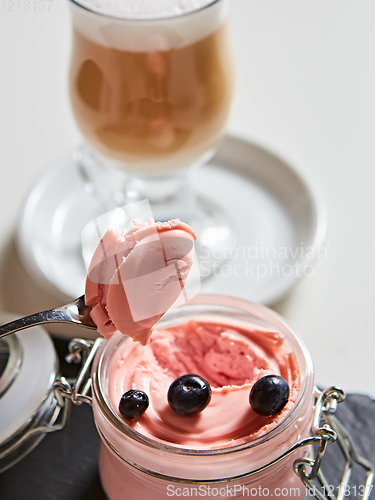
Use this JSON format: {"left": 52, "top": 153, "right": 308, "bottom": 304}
{"left": 70, "top": 0, "right": 235, "bottom": 274}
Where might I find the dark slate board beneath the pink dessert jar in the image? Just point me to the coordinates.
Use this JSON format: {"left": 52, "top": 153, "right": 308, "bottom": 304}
{"left": 0, "top": 338, "right": 375, "bottom": 500}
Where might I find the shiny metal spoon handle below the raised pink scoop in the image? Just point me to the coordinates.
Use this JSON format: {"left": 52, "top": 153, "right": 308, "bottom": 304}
{"left": 0, "top": 295, "right": 96, "bottom": 339}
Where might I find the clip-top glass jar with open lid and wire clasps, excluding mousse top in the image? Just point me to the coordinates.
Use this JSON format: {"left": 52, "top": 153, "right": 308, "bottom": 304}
{"left": 0, "top": 295, "right": 374, "bottom": 500}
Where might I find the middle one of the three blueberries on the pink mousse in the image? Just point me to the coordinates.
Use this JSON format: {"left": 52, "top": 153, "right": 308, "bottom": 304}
{"left": 168, "top": 373, "right": 211, "bottom": 416}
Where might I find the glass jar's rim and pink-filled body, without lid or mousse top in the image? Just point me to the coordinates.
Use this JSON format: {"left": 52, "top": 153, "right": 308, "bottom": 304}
{"left": 92, "top": 295, "right": 314, "bottom": 500}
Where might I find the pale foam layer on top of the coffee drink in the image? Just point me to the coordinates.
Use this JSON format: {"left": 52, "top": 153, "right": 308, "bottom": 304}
{"left": 71, "top": 0, "right": 227, "bottom": 52}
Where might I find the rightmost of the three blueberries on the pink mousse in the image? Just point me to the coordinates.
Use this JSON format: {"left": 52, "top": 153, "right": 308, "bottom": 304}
{"left": 249, "top": 375, "right": 289, "bottom": 416}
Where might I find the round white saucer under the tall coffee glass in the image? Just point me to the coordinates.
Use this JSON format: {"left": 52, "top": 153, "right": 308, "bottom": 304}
{"left": 17, "top": 136, "right": 327, "bottom": 305}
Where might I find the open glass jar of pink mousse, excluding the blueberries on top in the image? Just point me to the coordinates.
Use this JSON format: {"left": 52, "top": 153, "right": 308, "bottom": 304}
{"left": 92, "top": 295, "right": 314, "bottom": 500}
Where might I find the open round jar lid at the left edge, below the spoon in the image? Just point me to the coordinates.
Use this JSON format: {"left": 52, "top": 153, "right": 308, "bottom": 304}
{"left": 0, "top": 313, "right": 58, "bottom": 472}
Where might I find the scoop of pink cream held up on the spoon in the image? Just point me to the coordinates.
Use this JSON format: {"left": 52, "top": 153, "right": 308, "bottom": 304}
{"left": 85, "top": 219, "right": 196, "bottom": 345}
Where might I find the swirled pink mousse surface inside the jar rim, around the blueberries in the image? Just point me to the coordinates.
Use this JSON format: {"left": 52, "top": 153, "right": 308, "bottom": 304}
{"left": 108, "top": 320, "right": 300, "bottom": 449}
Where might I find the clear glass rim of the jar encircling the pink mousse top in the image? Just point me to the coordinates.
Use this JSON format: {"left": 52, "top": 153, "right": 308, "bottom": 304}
{"left": 92, "top": 294, "right": 314, "bottom": 456}
